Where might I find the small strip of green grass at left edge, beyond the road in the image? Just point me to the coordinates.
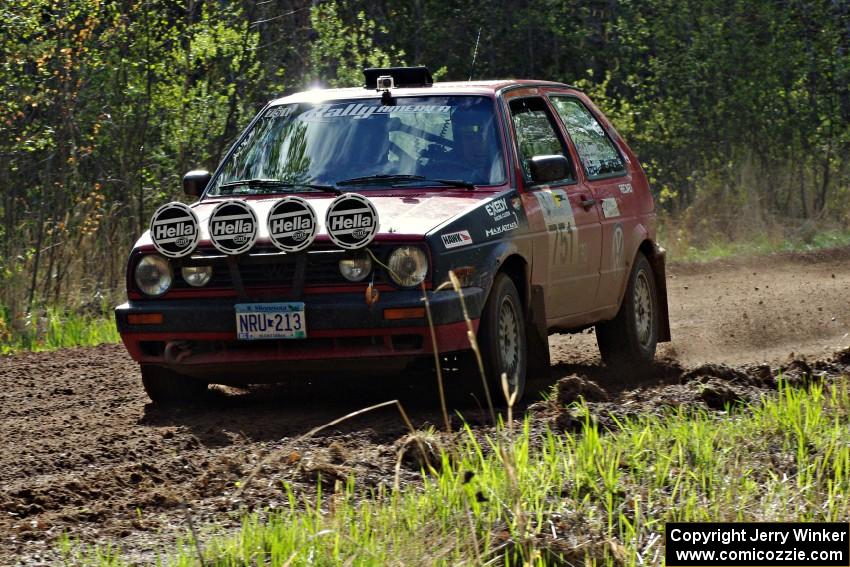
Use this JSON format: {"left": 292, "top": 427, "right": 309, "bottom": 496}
{"left": 0, "top": 309, "right": 121, "bottom": 355}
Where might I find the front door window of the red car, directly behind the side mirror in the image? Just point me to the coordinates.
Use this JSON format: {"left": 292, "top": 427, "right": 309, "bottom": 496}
{"left": 510, "top": 97, "right": 575, "bottom": 181}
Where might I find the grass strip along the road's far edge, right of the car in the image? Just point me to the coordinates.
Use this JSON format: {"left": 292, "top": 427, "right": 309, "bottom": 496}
{"left": 660, "top": 226, "right": 850, "bottom": 262}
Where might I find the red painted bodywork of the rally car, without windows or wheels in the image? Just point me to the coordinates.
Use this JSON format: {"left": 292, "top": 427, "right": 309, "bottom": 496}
{"left": 117, "top": 74, "right": 669, "bottom": 375}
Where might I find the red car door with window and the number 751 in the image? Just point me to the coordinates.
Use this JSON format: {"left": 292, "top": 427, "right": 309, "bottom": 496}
{"left": 508, "top": 96, "right": 602, "bottom": 326}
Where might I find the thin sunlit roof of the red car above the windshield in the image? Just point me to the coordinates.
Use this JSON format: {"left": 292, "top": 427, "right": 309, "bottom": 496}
{"left": 270, "top": 79, "right": 578, "bottom": 106}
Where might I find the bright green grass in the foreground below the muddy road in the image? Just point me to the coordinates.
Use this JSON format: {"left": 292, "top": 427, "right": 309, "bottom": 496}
{"left": 65, "top": 379, "right": 850, "bottom": 567}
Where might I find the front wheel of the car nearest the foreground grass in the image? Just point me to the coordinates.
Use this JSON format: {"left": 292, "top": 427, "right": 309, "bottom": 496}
{"left": 478, "top": 274, "right": 528, "bottom": 405}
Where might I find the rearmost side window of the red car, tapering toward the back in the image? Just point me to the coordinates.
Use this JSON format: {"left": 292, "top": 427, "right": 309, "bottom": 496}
{"left": 552, "top": 96, "right": 626, "bottom": 179}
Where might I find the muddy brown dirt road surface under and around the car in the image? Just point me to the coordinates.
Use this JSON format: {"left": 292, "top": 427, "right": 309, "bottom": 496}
{"left": 0, "top": 249, "right": 850, "bottom": 565}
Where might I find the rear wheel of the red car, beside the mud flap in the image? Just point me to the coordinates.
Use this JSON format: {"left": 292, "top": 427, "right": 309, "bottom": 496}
{"left": 596, "top": 253, "right": 658, "bottom": 365}
